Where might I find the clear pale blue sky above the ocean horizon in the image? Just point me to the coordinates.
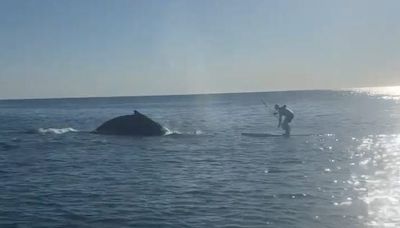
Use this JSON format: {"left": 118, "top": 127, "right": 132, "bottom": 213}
{"left": 0, "top": 0, "right": 400, "bottom": 99}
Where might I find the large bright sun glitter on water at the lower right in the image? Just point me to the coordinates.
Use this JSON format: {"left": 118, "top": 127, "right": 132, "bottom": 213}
{"left": 350, "top": 135, "right": 400, "bottom": 227}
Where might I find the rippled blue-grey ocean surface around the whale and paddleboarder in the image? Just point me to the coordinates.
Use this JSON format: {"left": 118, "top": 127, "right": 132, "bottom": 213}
{"left": 0, "top": 87, "right": 400, "bottom": 228}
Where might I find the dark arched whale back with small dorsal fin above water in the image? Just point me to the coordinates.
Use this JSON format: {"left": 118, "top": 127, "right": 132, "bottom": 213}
{"left": 93, "top": 110, "right": 167, "bottom": 136}
